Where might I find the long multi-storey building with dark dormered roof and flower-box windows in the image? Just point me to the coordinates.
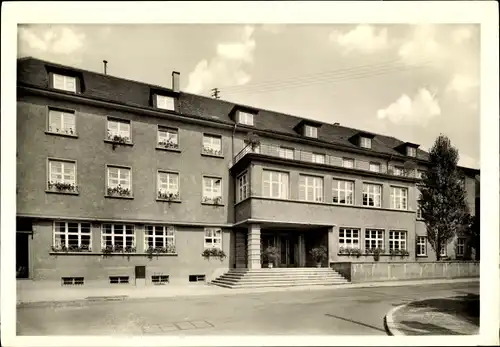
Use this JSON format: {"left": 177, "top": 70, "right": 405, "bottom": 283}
{"left": 16, "top": 58, "right": 478, "bottom": 284}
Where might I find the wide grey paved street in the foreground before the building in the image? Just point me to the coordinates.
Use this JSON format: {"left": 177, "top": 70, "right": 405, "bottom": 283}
{"left": 17, "top": 283, "right": 479, "bottom": 335}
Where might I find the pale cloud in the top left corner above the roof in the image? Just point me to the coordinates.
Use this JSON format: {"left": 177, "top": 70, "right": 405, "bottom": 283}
{"left": 19, "top": 26, "right": 86, "bottom": 55}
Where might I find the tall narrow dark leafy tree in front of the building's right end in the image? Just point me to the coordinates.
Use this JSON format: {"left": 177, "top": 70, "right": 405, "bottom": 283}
{"left": 419, "top": 135, "right": 469, "bottom": 261}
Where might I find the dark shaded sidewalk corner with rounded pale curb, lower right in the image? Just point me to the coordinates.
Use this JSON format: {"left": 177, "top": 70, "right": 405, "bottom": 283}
{"left": 385, "top": 294, "right": 479, "bottom": 336}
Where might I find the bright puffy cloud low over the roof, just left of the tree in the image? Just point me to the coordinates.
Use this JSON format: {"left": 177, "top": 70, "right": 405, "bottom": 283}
{"left": 377, "top": 88, "right": 441, "bottom": 126}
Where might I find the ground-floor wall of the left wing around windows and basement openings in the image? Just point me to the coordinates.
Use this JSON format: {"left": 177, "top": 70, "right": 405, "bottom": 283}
{"left": 31, "top": 220, "right": 234, "bottom": 284}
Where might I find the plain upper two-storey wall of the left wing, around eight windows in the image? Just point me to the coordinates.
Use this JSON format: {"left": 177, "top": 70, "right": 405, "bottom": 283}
{"left": 17, "top": 97, "right": 234, "bottom": 223}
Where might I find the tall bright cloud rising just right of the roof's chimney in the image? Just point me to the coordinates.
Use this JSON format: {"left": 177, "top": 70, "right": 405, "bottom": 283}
{"left": 186, "top": 26, "right": 256, "bottom": 94}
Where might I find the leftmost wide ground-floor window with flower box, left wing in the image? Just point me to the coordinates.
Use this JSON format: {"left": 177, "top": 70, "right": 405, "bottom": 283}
{"left": 53, "top": 221, "right": 92, "bottom": 251}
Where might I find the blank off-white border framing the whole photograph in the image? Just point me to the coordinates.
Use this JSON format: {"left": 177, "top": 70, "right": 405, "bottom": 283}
{"left": 1, "top": 1, "right": 500, "bottom": 346}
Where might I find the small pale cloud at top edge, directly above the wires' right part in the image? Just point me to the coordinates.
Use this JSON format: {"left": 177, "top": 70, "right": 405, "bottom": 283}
{"left": 329, "top": 24, "right": 389, "bottom": 54}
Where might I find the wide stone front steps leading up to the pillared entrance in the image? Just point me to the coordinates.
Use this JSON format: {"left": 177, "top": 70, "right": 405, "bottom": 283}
{"left": 211, "top": 268, "right": 349, "bottom": 288}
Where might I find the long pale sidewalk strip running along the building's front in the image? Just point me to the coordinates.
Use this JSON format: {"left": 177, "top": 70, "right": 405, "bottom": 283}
{"left": 17, "top": 278, "right": 479, "bottom": 306}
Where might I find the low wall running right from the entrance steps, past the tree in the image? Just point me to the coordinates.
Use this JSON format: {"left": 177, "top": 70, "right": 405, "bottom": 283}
{"left": 330, "top": 261, "right": 479, "bottom": 283}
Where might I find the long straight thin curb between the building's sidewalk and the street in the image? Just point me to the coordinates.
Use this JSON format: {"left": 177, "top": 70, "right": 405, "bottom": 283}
{"left": 16, "top": 278, "right": 479, "bottom": 310}
